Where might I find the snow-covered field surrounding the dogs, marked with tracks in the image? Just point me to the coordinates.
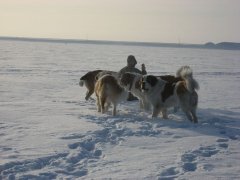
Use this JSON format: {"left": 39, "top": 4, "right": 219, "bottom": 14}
{"left": 0, "top": 40, "right": 240, "bottom": 179}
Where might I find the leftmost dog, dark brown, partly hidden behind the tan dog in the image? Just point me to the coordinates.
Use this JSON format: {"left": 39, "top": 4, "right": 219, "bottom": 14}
{"left": 79, "top": 70, "right": 117, "bottom": 100}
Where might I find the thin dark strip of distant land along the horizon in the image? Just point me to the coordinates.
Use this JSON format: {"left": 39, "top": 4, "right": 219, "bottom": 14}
{"left": 0, "top": 36, "right": 240, "bottom": 50}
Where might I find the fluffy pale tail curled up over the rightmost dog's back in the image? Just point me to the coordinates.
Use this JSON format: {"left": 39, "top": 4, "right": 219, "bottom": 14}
{"left": 176, "top": 66, "right": 199, "bottom": 92}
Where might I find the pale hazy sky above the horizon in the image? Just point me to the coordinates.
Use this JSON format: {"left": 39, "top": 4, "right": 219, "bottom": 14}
{"left": 0, "top": 0, "right": 240, "bottom": 44}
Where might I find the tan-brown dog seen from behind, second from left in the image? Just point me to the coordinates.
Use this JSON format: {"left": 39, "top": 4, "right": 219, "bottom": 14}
{"left": 95, "top": 74, "right": 128, "bottom": 116}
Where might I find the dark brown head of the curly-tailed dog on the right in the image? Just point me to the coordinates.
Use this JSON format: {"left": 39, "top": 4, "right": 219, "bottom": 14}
{"left": 140, "top": 75, "right": 158, "bottom": 92}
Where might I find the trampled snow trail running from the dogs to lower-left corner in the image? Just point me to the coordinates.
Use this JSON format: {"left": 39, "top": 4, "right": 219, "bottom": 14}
{"left": 0, "top": 109, "right": 169, "bottom": 179}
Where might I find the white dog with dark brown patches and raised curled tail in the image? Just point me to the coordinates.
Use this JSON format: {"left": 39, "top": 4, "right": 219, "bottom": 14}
{"left": 140, "top": 66, "right": 199, "bottom": 123}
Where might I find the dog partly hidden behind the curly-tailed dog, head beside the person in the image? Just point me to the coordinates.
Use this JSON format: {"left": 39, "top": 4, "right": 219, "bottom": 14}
{"left": 120, "top": 72, "right": 183, "bottom": 111}
